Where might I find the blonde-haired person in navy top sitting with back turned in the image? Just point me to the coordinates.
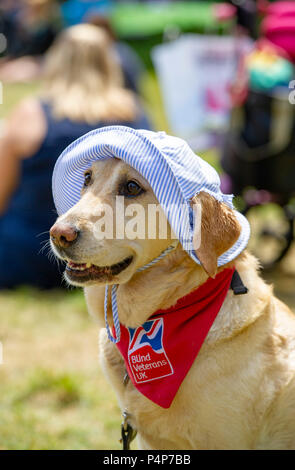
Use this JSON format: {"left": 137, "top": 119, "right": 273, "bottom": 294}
{"left": 0, "top": 24, "right": 153, "bottom": 289}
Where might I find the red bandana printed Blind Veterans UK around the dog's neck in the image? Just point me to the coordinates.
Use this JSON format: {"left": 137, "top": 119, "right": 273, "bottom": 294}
{"left": 117, "top": 269, "right": 234, "bottom": 408}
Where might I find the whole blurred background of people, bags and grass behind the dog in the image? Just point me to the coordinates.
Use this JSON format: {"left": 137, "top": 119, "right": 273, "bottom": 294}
{"left": 0, "top": 0, "right": 295, "bottom": 449}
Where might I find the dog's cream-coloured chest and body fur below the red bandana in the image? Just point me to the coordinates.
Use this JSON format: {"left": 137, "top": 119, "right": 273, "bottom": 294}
{"left": 86, "top": 258, "right": 295, "bottom": 450}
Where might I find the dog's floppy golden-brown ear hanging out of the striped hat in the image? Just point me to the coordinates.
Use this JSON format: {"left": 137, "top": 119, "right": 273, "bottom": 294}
{"left": 191, "top": 192, "right": 241, "bottom": 277}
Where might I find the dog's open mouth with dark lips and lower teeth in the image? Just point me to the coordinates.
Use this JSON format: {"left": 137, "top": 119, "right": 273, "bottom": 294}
{"left": 66, "top": 256, "right": 133, "bottom": 282}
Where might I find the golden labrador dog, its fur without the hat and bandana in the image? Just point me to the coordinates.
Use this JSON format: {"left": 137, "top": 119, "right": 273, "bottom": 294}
{"left": 51, "top": 159, "right": 295, "bottom": 450}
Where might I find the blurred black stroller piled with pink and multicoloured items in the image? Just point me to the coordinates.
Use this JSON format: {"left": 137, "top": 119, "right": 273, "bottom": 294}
{"left": 221, "top": 1, "right": 295, "bottom": 268}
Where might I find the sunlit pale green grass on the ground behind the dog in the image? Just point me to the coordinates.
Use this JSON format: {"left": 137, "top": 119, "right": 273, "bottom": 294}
{"left": 0, "top": 75, "right": 295, "bottom": 450}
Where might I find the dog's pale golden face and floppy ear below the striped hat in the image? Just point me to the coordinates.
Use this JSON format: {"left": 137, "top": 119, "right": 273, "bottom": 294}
{"left": 50, "top": 158, "right": 241, "bottom": 286}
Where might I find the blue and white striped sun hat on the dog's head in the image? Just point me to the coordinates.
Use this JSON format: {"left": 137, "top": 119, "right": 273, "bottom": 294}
{"left": 53, "top": 126, "right": 250, "bottom": 266}
